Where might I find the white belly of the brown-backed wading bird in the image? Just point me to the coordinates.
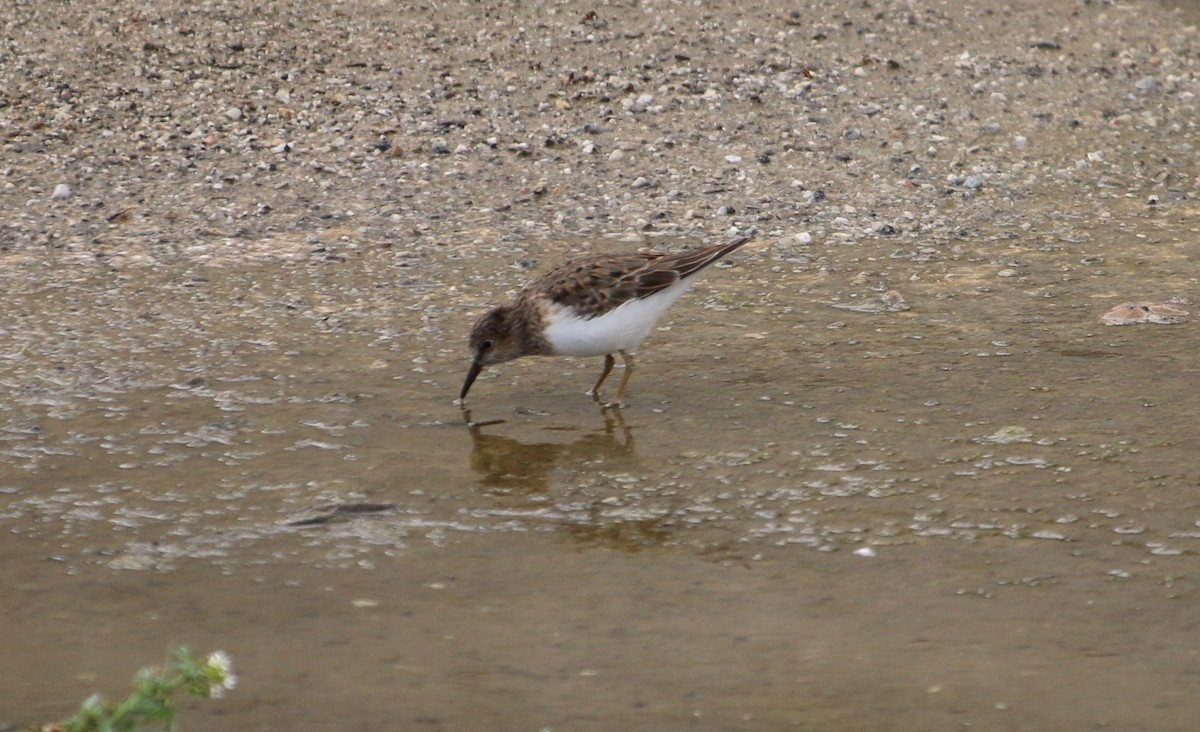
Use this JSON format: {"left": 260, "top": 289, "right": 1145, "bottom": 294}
{"left": 545, "top": 278, "right": 691, "bottom": 356}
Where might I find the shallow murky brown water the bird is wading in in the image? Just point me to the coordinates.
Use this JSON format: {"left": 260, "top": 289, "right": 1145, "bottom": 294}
{"left": 0, "top": 206, "right": 1200, "bottom": 731}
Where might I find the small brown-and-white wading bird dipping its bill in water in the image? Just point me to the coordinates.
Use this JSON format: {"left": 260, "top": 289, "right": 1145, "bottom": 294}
{"left": 458, "top": 236, "right": 750, "bottom": 408}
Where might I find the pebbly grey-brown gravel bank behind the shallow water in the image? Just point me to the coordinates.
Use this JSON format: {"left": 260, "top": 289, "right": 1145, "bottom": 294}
{"left": 0, "top": 0, "right": 1200, "bottom": 266}
